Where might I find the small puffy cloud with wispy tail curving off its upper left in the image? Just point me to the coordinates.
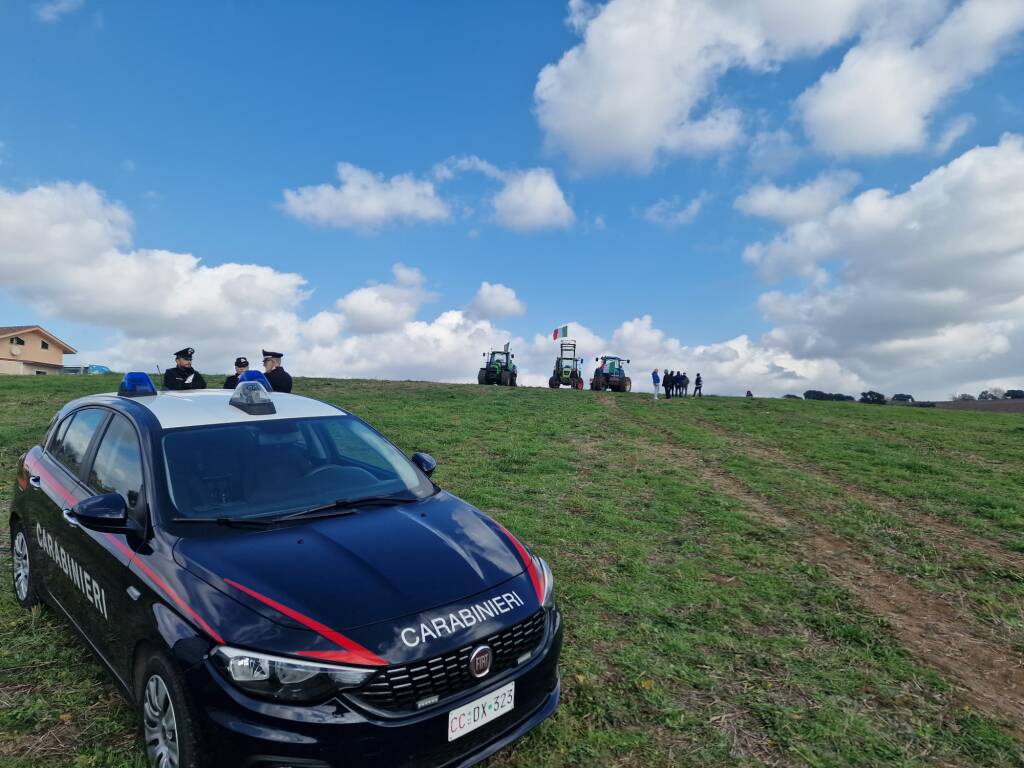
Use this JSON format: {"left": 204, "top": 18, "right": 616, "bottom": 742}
{"left": 433, "top": 155, "right": 575, "bottom": 232}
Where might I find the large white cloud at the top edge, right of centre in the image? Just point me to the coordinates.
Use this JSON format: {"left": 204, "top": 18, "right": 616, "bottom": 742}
{"left": 534, "top": 0, "right": 878, "bottom": 171}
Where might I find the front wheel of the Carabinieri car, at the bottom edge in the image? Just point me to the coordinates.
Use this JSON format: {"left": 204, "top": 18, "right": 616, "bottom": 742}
{"left": 135, "top": 652, "right": 206, "bottom": 768}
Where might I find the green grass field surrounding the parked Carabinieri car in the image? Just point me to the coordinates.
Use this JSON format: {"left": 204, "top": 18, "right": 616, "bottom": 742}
{"left": 0, "top": 377, "right": 1024, "bottom": 768}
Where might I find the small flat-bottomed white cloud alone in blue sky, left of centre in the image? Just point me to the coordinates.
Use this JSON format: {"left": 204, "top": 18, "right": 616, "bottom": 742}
{"left": 284, "top": 163, "right": 451, "bottom": 231}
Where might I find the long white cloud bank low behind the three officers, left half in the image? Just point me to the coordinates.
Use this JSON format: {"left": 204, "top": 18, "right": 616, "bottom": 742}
{"left": 0, "top": 183, "right": 524, "bottom": 381}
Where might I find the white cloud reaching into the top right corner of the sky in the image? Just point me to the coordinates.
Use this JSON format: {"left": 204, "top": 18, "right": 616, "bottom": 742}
{"left": 797, "top": 0, "right": 1024, "bottom": 156}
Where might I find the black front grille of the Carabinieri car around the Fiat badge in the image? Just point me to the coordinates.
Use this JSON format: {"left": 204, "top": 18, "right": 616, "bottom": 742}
{"left": 354, "top": 609, "right": 545, "bottom": 713}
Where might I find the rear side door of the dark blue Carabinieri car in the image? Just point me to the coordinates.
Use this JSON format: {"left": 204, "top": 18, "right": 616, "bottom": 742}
{"left": 29, "top": 408, "right": 110, "bottom": 642}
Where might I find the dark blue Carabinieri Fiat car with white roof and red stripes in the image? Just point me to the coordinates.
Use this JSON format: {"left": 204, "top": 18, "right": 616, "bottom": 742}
{"left": 10, "top": 373, "right": 562, "bottom": 768}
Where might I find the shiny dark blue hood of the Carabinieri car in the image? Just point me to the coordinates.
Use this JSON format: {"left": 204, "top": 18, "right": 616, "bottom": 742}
{"left": 174, "top": 492, "right": 524, "bottom": 630}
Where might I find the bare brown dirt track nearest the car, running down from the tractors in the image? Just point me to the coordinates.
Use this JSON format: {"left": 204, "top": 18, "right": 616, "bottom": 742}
{"left": 606, "top": 398, "right": 1024, "bottom": 738}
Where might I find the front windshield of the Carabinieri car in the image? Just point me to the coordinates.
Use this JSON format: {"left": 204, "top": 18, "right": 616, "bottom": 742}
{"left": 163, "top": 416, "right": 433, "bottom": 518}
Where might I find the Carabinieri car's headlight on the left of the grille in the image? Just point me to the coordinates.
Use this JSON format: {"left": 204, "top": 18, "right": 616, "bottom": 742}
{"left": 210, "top": 645, "right": 377, "bottom": 702}
